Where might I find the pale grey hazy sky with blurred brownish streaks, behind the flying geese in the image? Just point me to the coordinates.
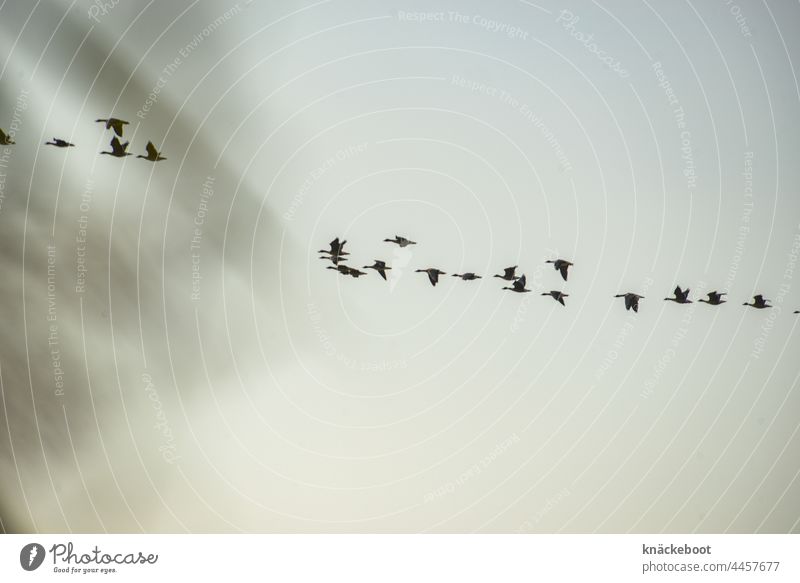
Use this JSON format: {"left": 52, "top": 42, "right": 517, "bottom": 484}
{"left": 0, "top": 0, "right": 800, "bottom": 533}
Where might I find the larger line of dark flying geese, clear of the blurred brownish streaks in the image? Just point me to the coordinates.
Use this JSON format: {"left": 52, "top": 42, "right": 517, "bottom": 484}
{"left": 318, "top": 235, "right": 800, "bottom": 314}
